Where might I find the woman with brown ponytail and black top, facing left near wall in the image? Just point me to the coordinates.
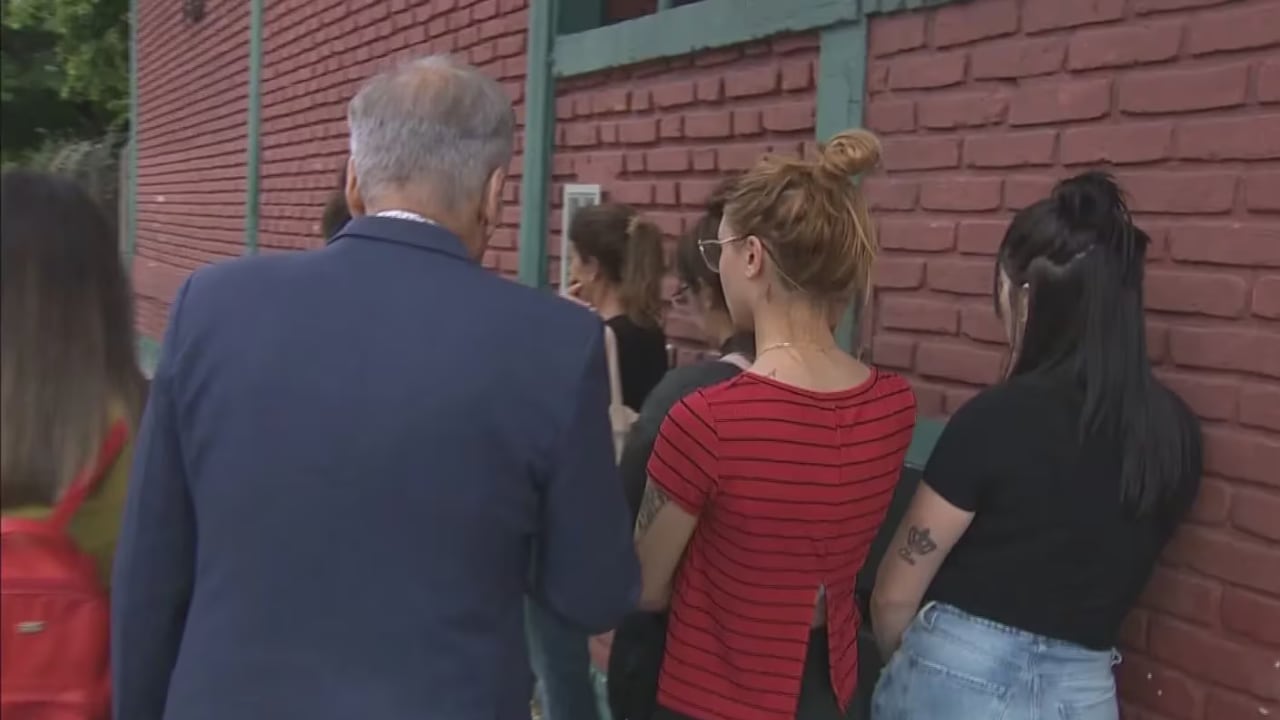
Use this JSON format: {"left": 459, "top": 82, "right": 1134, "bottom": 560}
{"left": 568, "top": 202, "right": 667, "bottom": 413}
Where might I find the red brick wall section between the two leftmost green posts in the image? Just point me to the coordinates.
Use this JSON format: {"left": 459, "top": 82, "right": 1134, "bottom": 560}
{"left": 133, "top": 0, "right": 248, "bottom": 337}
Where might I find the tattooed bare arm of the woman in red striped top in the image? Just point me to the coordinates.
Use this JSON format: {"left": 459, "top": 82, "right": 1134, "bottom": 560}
{"left": 635, "top": 479, "right": 698, "bottom": 611}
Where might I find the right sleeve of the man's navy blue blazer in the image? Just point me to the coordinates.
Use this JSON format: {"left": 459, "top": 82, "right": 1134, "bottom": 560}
{"left": 534, "top": 322, "right": 640, "bottom": 633}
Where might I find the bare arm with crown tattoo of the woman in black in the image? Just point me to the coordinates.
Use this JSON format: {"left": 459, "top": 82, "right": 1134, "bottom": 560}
{"left": 872, "top": 483, "right": 973, "bottom": 659}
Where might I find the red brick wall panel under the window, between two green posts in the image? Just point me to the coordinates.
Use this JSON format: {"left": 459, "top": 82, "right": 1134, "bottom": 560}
{"left": 549, "top": 35, "right": 818, "bottom": 358}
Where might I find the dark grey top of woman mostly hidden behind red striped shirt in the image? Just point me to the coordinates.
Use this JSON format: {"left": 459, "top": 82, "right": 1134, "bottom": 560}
{"left": 618, "top": 336, "right": 755, "bottom": 523}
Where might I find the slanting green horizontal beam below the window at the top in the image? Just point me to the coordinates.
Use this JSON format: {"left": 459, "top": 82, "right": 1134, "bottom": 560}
{"left": 552, "top": 0, "right": 860, "bottom": 77}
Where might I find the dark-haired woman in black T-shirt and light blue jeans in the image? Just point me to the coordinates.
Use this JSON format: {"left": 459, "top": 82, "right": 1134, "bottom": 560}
{"left": 872, "top": 173, "right": 1202, "bottom": 720}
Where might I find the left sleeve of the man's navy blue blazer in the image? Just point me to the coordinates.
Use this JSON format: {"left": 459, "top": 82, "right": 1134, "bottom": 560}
{"left": 111, "top": 272, "right": 196, "bottom": 720}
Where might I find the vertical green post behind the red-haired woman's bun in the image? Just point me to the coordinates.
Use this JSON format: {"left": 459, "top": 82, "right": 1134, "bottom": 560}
{"left": 815, "top": 20, "right": 867, "bottom": 354}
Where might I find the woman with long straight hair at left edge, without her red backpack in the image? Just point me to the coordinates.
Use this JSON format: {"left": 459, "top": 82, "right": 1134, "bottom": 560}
{"left": 0, "top": 172, "right": 146, "bottom": 583}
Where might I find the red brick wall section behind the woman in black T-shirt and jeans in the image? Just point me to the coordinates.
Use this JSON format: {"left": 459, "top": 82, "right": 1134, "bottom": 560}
{"left": 867, "top": 0, "right": 1280, "bottom": 720}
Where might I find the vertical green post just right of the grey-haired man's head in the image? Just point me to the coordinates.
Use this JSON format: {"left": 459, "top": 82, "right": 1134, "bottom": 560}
{"left": 517, "top": 0, "right": 559, "bottom": 287}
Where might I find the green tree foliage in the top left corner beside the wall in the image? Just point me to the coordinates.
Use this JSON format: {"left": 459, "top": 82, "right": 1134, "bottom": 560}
{"left": 0, "top": 0, "right": 129, "bottom": 164}
